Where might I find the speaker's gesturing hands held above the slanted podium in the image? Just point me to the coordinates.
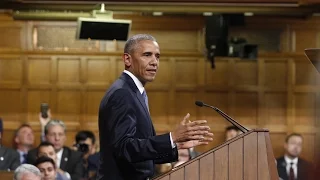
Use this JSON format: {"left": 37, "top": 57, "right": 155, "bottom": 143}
{"left": 171, "top": 113, "right": 213, "bottom": 147}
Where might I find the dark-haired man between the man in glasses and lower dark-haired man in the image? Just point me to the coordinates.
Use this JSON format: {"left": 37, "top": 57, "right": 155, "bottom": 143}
{"left": 37, "top": 142, "right": 68, "bottom": 179}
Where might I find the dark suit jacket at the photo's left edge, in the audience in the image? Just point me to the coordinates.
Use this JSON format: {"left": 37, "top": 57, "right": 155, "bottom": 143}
{"left": 0, "top": 146, "right": 21, "bottom": 171}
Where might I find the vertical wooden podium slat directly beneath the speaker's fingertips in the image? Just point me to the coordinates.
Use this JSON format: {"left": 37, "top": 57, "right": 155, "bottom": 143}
{"left": 200, "top": 153, "right": 215, "bottom": 180}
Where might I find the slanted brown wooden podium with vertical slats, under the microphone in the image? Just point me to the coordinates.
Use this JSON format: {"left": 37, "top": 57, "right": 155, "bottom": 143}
{"left": 154, "top": 129, "right": 279, "bottom": 180}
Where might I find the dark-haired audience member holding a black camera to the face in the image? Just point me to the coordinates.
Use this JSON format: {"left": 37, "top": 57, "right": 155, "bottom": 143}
{"left": 74, "top": 130, "right": 100, "bottom": 178}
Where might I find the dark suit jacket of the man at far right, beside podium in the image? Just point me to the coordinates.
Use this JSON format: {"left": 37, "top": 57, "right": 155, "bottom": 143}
{"left": 277, "top": 156, "right": 314, "bottom": 180}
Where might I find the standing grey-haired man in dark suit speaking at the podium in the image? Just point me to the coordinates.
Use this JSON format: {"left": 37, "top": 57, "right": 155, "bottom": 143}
{"left": 98, "top": 34, "right": 212, "bottom": 180}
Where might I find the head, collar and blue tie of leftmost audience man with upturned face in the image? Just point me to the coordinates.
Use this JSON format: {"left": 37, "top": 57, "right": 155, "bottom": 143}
{"left": 14, "top": 124, "right": 34, "bottom": 164}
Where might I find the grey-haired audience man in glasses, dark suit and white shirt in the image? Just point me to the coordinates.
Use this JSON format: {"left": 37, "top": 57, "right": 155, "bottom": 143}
{"left": 27, "top": 120, "right": 84, "bottom": 180}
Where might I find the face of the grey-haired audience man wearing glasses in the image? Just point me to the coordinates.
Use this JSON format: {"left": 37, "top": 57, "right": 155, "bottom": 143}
{"left": 46, "top": 125, "right": 66, "bottom": 151}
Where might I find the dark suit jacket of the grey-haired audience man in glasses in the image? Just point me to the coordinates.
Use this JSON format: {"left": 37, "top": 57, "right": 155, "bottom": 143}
{"left": 27, "top": 147, "right": 84, "bottom": 180}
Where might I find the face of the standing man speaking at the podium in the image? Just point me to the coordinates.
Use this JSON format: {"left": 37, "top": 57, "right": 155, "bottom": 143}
{"left": 123, "top": 40, "right": 160, "bottom": 84}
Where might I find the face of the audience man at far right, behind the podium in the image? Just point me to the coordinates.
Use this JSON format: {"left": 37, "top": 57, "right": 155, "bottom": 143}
{"left": 284, "top": 136, "right": 302, "bottom": 157}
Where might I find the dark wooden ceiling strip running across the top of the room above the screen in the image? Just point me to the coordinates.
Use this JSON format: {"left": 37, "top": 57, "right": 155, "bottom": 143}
{"left": 2, "top": 0, "right": 320, "bottom": 17}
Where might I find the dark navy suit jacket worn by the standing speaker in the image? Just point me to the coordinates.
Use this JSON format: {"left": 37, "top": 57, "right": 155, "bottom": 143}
{"left": 98, "top": 73, "right": 178, "bottom": 180}
